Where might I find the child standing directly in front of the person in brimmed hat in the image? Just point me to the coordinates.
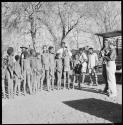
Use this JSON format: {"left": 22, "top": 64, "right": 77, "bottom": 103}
{"left": 23, "top": 51, "right": 32, "bottom": 95}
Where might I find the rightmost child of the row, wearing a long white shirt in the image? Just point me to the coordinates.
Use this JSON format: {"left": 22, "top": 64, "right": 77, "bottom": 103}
{"left": 88, "top": 48, "right": 98, "bottom": 85}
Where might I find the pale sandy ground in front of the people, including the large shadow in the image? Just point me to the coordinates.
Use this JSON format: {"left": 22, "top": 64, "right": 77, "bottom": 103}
{"left": 2, "top": 84, "right": 122, "bottom": 124}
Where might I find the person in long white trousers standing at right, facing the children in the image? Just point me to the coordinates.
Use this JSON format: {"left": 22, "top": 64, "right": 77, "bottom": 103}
{"left": 104, "top": 42, "right": 117, "bottom": 97}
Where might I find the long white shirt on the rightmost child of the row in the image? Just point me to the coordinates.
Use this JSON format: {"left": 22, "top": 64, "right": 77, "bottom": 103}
{"left": 88, "top": 53, "right": 98, "bottom": 68}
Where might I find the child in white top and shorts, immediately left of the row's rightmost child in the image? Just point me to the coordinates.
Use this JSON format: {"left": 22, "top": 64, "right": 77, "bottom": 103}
{"left": 79, "top": 48, "right": 88, "bottom": 85}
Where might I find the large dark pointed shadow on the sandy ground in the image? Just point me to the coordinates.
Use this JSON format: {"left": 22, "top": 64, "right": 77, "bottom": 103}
{"left": 63, "top": 98, "right": 122, "bottom": 123}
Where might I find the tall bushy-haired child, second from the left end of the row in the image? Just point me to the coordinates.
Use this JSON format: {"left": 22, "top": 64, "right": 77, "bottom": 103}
{"left": 7, "top": 47, "right": 14, "bottom": 98}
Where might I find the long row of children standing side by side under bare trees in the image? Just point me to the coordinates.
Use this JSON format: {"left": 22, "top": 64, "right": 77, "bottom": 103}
{"left": 2, "top": 45, "right": 98, "bottom": 98}
